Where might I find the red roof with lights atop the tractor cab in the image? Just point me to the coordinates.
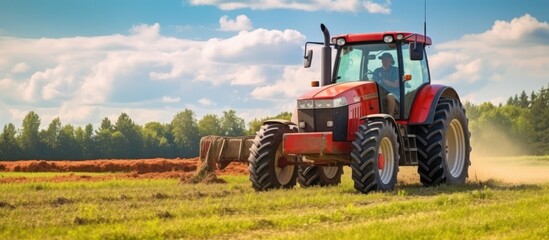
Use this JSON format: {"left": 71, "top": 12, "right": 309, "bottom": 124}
{"left": 332, "top": 32, "right": 432, "bottom": 45}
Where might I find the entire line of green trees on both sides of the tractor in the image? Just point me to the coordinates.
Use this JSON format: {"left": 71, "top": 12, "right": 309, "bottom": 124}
{"left": 0, "top": 83, "right": 549, "bottom": 160}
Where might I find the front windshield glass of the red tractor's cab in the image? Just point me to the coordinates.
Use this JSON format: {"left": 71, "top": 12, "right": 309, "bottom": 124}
{"left": 336, "top": 43, "right": 398, "bottom": 83}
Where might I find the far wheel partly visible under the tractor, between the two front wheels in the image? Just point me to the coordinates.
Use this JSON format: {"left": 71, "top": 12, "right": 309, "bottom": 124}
{"left": 297, "top": 164, "right": 343, "bottom": 187}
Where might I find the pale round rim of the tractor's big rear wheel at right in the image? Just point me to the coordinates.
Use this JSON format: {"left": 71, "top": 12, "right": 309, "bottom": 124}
{"left": 446, "top": 119, "right": 465, "bottom": 178}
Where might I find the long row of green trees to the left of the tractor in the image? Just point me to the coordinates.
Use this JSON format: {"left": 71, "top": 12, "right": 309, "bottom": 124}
{"left": 0, "top": 109, "right": 291, "bottom": 160}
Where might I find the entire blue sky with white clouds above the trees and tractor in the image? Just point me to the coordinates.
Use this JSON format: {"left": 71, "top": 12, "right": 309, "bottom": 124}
{"left": 0, "top": 0, "right": 549, "bottom": 127}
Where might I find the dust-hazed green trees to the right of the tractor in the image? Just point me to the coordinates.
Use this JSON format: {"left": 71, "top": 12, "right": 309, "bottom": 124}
{"left": 465, "top": 84, "right": 549, "bottom": 155}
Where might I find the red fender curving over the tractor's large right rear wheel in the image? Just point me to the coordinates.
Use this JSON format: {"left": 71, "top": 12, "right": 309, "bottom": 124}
{"left": 408, "top": 84, "right": 459, "bottom": 125}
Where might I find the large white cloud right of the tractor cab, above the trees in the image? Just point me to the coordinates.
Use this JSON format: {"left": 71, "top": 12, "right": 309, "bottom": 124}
{"left": 429, "top": 14, "right": 549, "bottom": 102}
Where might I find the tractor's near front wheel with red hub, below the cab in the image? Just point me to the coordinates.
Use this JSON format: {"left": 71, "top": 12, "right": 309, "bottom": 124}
{"left": 351, "top": 120, "right": 400, "bottom": 193}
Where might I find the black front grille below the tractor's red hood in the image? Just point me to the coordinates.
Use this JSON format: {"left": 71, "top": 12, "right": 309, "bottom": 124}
{"left": 298, "top": 106, "right": 349, "bottom": 141}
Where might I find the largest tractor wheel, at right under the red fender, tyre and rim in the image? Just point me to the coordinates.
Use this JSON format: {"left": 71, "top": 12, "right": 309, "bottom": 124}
{"left": 416, "top": 98, "right": 471, "bottom": 186}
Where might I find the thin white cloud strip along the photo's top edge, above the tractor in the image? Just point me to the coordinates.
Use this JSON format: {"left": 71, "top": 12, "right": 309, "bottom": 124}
{"left": 189, "top": 0, "right": 390, "bottom": 12}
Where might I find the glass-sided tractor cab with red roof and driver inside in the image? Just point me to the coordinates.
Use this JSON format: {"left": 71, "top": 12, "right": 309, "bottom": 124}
{"left": 305, "top": 32, "right": 431, "bottom": 120}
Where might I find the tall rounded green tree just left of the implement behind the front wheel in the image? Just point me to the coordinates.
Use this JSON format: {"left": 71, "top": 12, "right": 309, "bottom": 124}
{"left": 171, "top": 109, "right": 200, "bottom": 157}
